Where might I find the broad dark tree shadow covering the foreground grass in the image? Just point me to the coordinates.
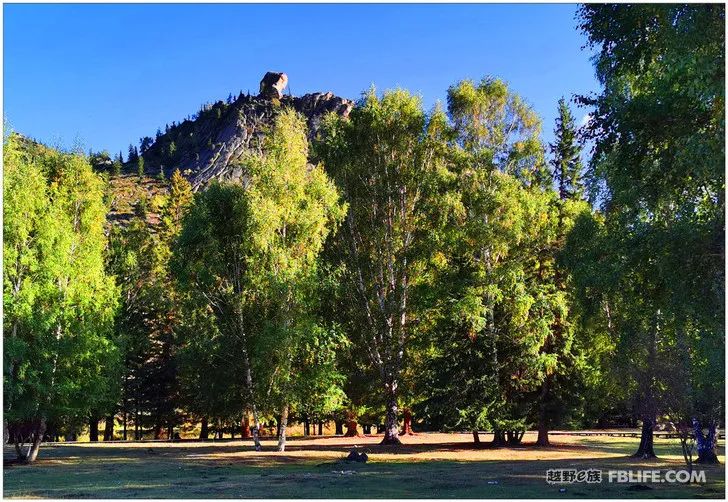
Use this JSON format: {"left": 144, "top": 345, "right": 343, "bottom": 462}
{"left": 5, "top": 443, "right": 724, "bottom": 498}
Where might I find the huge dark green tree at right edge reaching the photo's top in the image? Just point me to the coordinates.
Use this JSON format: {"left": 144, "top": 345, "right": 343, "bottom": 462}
{"left": 576, "top": 4, "right": 725, "bottom": 458}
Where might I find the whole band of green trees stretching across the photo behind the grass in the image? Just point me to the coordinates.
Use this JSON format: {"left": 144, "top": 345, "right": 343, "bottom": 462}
{"left": 3, "top": 4, "right": 725, "bottom": 462}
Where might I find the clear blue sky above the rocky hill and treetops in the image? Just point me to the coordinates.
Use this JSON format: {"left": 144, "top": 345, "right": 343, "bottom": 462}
{"left": 4, "top": 4, "right": 598, "bottom": 155}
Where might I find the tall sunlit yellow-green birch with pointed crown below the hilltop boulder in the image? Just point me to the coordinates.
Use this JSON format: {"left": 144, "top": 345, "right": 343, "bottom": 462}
{"left": 245, "top": 110, "right": 345, "bottom": 451}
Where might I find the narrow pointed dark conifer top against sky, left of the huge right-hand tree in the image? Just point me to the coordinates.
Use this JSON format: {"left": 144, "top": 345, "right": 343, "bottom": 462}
{"left": 549, "top": 98, "right": 583, "bottom": 200}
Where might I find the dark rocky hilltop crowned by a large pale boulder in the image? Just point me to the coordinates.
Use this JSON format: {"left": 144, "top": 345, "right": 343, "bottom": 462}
{"left": 139, "top": 72, "right": 354, "bottom": 190}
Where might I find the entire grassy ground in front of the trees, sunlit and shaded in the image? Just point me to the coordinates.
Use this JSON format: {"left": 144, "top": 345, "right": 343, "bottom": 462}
{"left": 3, "top": 433, "right": 725, "bottom": 498}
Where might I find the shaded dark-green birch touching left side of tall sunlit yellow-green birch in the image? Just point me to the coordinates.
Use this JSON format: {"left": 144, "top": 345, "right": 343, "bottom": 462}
{"left": 172, "top": 183, "right": 261, "bottom": 448}
